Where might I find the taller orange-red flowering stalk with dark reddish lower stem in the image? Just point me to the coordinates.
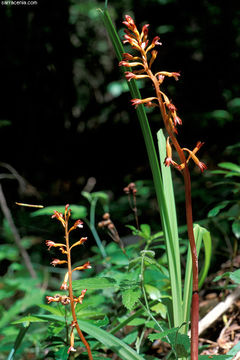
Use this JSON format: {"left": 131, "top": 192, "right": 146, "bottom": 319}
{"left": 119, "top": 15, "right": 206, "bottom": 360}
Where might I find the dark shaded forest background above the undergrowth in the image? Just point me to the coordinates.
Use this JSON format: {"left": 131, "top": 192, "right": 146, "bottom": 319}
{"left": 0, "top": 0, "right": 240, "bottom": 222}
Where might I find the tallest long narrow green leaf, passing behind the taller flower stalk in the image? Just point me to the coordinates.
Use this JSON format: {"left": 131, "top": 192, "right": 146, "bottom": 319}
{"left": 100, "top": 9, "right": 183, "bottom": 327}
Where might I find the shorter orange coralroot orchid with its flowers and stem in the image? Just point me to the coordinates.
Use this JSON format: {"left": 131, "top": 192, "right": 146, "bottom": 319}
{"left": 46, "top": 205, "right": 93, "bottom": 360}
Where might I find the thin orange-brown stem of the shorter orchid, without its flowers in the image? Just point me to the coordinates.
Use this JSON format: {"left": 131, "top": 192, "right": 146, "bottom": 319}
{"left": 65, "top": 219, "right": 93, "bottom": 360}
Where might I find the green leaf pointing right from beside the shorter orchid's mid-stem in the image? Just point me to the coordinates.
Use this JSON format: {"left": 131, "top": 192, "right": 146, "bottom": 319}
{"left": 73, "top": 277, "right": 117, "bottom": 290}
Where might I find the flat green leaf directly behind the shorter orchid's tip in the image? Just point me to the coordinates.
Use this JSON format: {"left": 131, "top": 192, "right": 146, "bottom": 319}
{"left": 31, "top": 205, "right": 87, "bottom": 220}
